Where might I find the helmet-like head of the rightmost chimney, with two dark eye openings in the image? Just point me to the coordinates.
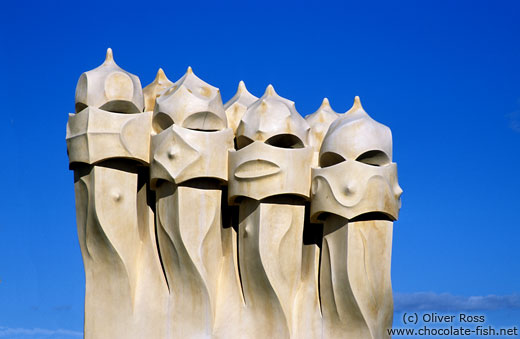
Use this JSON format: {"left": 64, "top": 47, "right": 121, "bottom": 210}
{"left": 311, "top": 97, "right": 402, "bottom": 221}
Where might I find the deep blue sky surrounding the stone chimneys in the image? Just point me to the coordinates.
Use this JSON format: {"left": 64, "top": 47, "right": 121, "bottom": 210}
{"left": 0, "top": 0, "right": 520, "bottom": 338}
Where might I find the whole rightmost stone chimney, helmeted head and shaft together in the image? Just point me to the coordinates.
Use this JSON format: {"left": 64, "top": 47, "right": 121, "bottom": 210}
{"left": 311, "top": 97, "right": 402, "bottom": 338}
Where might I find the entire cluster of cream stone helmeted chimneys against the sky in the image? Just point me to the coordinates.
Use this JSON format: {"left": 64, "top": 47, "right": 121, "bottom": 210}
{"left": 67, "top": 49, "right": 402, "bottom": 338}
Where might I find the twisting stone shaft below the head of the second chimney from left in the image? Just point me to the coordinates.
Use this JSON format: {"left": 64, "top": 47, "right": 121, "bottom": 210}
{"left": 157, "top": 183, "right": 222, "bottom": 338}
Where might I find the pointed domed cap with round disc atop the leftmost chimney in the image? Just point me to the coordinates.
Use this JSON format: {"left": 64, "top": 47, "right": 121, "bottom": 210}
{"left": 76, "top": 48, "right": 144, "bottom": 113}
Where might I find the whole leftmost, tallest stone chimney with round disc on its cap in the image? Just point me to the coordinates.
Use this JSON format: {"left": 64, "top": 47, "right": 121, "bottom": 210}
{"left": 67, "top": 49, "right": 168, "bottom": 338}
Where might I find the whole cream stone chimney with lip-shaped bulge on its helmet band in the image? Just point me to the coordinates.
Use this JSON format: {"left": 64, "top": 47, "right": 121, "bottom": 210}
{"left": 229, "top": 85, "right": 319, "bottom": 338}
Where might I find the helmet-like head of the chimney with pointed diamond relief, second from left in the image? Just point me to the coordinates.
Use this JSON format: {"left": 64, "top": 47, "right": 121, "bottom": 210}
{"left": 150, "top": 68, "right": 234, "bottom": 187}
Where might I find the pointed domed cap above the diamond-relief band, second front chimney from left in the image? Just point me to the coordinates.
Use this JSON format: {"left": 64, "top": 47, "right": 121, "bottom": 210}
{"left": 153, "top": 67, "right": 227, "bottom": 133}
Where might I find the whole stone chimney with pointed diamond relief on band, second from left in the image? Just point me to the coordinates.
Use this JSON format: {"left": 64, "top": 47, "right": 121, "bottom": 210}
{"left": 150, "top": 68, "right": 233, "bottom": 338}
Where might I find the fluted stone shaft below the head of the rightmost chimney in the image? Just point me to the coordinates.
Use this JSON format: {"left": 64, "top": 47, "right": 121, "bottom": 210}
{"left": 320, "top": 215, "right": 393, "bottom": 338}
